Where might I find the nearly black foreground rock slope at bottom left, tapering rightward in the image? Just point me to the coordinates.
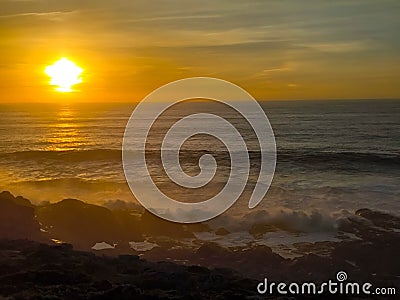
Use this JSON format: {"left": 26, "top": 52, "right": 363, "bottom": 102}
{"left": 0, "top": 240, "right": 256, "bottom": 299}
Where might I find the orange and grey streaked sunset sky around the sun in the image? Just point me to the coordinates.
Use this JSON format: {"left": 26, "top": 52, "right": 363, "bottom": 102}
{"left": 0, "top": 0, "right": 400, "bottom": 102}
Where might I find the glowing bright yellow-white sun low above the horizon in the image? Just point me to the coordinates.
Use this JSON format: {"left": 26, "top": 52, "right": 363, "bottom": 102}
{"left": 44, "top": 57, "right": 83, "bottom": 93}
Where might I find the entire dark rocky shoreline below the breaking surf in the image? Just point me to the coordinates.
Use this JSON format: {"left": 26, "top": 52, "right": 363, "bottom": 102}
{"left": 0, "top": 192, "right": 400, "bottom": 299}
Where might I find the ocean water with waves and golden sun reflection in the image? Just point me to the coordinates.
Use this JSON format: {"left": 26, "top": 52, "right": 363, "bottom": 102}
{"left": 0, "top": 100, "right": 400, "bottom": 253}
